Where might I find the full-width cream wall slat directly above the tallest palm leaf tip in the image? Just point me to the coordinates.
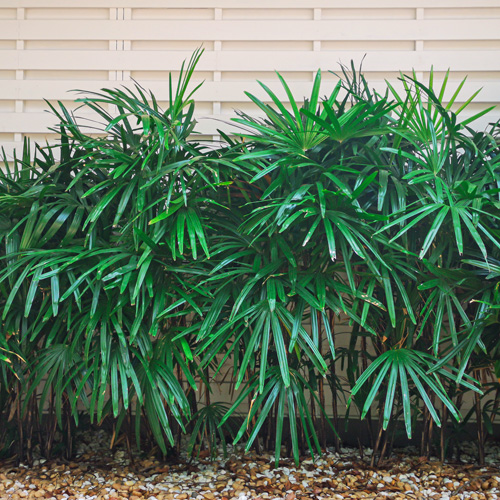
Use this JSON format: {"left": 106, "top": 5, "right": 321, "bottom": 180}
{"left": 4, "top": 19, "right": 500, "bottom": 42}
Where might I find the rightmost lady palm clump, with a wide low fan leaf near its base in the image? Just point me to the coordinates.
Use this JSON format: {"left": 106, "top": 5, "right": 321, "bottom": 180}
{"left": 344, "top": 69, "right": 498, "bottom": 460}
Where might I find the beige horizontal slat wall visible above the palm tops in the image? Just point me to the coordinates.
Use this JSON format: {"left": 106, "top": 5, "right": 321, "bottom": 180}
{"left": 0, "top": 0, "right": 500, "bottom": 158}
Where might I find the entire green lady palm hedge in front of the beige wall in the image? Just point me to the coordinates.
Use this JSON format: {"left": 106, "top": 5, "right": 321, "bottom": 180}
{"left": 0, "top": 51, "right": 500, "bottom": 461}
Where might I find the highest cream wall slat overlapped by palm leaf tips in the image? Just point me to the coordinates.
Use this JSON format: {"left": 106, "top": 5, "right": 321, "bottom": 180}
{"left": 4, "top": 50, "right": 500, "bottom": 72}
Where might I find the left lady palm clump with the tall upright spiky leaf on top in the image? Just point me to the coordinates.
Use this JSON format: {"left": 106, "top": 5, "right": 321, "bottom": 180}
{"left": 0, "top": 48, "right": 236, "bottom": 458}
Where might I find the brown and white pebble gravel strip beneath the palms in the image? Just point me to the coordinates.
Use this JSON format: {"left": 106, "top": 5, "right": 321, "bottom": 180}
{"left": 0, "top": 433, "right": 500, "bottom": 500}
